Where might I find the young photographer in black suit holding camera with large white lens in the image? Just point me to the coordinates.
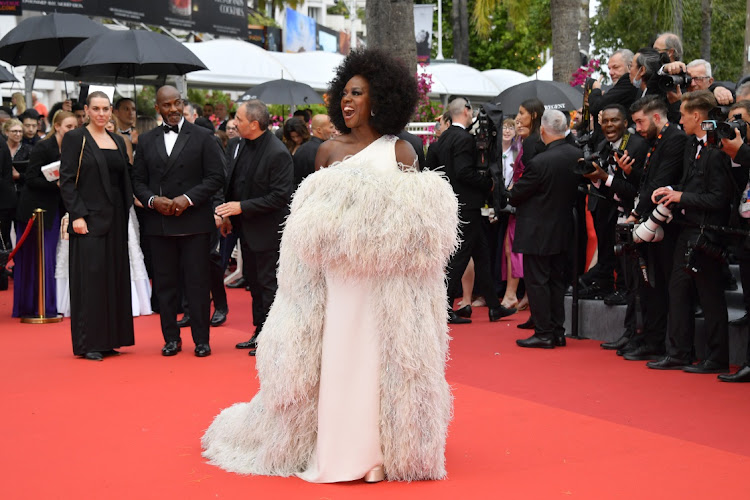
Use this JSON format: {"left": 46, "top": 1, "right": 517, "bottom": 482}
{"left": 647, "top": 90, "right": 733, "bottom": 373}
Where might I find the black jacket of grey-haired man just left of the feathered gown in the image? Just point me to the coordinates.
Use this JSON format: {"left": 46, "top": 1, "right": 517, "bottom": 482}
{"left": 225, "top": 131, "right": 294, "bottom": 252}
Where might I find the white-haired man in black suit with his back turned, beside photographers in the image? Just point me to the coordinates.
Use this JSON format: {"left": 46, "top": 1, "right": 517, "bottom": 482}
{"left": 509, "top": 110, "right": 583, "bottom": 349}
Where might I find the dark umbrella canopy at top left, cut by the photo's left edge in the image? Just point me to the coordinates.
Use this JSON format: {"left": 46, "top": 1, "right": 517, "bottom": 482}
{"left": 0, "top": 14, "right": 109, "bottom": 66}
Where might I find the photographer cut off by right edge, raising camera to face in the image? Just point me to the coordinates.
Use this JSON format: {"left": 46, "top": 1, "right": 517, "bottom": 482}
{"left": 719, "top": 100, "right": 750, "bottom": 382}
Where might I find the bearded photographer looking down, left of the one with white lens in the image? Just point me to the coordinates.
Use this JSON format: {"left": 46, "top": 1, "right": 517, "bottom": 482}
{"left": 618, "top": 96, "right": 687, "bottom": 361}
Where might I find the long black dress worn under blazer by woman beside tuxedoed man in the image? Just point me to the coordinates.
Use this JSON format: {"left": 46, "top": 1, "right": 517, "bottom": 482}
{"left": 70, "top": 148, "right": 135, "bottom": 356}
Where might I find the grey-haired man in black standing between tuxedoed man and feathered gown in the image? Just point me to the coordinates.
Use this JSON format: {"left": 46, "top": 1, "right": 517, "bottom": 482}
{"left": 216, "top": 100, "right": 294, "bottom": 356}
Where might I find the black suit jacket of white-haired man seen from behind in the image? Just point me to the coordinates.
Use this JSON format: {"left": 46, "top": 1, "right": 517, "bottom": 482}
{"left": 509, "top": 139, "right": 583, "bottom": 255}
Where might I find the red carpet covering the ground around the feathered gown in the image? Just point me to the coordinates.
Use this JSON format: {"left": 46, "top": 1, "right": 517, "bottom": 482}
{"left": 0, "top": 284, "right": 750, "bottom": 500}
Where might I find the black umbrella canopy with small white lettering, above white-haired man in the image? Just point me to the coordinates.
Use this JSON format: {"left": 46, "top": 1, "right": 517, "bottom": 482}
{"left": 494, "top": 80, "right": 583, "bottom": 115}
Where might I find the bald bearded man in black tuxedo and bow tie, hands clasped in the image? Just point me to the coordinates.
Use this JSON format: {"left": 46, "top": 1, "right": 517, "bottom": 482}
{"left": 133, "top": 86, "right": 224, "bottom": 357}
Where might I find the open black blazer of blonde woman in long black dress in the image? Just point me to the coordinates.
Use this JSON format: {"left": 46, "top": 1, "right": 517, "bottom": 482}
{"left": 60, "top": 127, "right": 133, "bottom": 236}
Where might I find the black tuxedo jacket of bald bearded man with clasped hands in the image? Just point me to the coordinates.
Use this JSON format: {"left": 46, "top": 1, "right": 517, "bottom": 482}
{"left": 133, "top": 121, "right": 224, "bottom": 236}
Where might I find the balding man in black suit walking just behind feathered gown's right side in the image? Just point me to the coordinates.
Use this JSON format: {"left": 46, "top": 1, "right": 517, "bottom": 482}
{"left": 427, "top": 97, "right": 516, "bottom": 324}
